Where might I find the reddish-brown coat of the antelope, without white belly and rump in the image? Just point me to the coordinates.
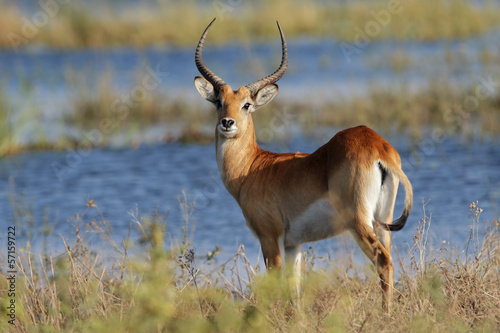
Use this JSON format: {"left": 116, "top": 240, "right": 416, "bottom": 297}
{"left": 197, "top": 81, "right": 411, "bottom": 309}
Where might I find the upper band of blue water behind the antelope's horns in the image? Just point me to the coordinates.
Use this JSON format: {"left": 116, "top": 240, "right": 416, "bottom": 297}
{"left": 0, "top": 27, "right": 500, "bottom": 118}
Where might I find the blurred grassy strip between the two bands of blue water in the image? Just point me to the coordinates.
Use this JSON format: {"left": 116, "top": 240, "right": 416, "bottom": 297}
{"left": 0, "top": 77, "right": 500, "bottom": 156}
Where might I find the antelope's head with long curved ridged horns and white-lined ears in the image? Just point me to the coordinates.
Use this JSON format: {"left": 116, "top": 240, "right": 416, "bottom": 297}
{"left": 194, "top": 19, "right": 288, "bottom": 139}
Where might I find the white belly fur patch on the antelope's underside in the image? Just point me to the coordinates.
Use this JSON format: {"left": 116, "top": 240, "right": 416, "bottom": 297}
{"left": 285, "top": 199, "right": 343, "bottom": 246}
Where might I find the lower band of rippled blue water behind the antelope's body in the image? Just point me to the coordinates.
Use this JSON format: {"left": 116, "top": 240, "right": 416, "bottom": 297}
{"left": 0, "top": 129, "right": 500, "bottom": 268}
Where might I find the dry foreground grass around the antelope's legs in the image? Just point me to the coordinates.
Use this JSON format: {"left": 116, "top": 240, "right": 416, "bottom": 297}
{"left": 0, "top": 200, "right": 500, "bottom": 332}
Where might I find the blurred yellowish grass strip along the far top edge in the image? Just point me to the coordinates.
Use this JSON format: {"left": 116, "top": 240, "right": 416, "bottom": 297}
{"left": 0, "top": 0, "right": 500, "bottom": 49}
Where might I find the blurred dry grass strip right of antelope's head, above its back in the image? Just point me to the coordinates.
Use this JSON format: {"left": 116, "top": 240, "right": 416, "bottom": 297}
{"left": 278, "top": 81, "right": 500, "bottom": 140}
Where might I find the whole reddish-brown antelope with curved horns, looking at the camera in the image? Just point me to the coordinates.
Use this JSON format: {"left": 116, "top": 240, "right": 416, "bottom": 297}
{"left": 194, "top": 19, "right": 413, "bottom": 311}
